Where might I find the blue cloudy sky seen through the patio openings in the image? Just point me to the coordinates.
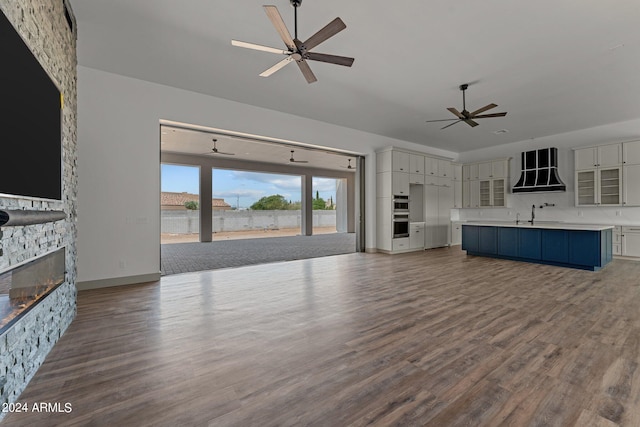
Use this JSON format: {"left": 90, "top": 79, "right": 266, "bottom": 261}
{"left": 161, "top": 164, "right": 336, "bottom": 209}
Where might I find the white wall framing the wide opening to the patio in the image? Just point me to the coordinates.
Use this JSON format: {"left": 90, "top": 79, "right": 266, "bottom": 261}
{"left": 78, "top": 66, "right": 456, "bottom": 283}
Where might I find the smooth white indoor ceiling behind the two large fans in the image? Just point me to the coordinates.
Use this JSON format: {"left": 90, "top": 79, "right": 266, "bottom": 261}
{"left": 71, "top": 0, "right": 640, "bottom": 152}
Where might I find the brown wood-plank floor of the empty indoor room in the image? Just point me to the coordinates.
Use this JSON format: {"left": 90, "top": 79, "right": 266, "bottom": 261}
{"left": 4, "top": 247, "right": 640, "bottom": 427}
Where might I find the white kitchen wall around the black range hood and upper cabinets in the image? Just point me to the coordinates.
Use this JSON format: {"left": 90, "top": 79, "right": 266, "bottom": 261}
{"left": 452, "top": 120, "right": 640, "bottom": 225}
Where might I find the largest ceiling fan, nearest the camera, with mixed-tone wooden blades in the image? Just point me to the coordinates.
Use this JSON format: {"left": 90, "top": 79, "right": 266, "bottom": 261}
{"left": 231, "top": 0, "right": 354, "bottom": 83}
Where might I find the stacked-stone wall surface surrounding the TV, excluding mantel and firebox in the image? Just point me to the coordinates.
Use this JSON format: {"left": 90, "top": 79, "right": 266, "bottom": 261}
{"left": 0, "top": 0, "right": 77, "bottom": 419}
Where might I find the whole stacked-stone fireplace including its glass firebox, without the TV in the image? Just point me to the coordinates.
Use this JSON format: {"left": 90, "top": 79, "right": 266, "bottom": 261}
{"left": 0, "top": 0, "right": 78, "bottom": 419}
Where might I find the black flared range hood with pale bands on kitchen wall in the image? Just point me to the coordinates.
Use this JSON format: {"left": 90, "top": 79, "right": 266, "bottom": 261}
{"left": 512, "top": 148, "right": 567, "bottom": 193}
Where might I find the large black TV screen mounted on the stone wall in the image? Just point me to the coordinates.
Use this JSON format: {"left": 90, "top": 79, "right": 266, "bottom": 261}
{"left": 0, "top": 11, "right": 62, "bottom": 200}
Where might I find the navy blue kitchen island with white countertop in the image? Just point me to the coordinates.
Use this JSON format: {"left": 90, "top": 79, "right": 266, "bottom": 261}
{"left": 462, "top": 221, "right": 613, "bottom": 271}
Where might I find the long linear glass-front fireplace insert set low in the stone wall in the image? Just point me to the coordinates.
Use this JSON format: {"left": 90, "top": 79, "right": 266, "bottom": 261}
{"left": 0, "top": 247, "right": 65, "bottom": 335}
